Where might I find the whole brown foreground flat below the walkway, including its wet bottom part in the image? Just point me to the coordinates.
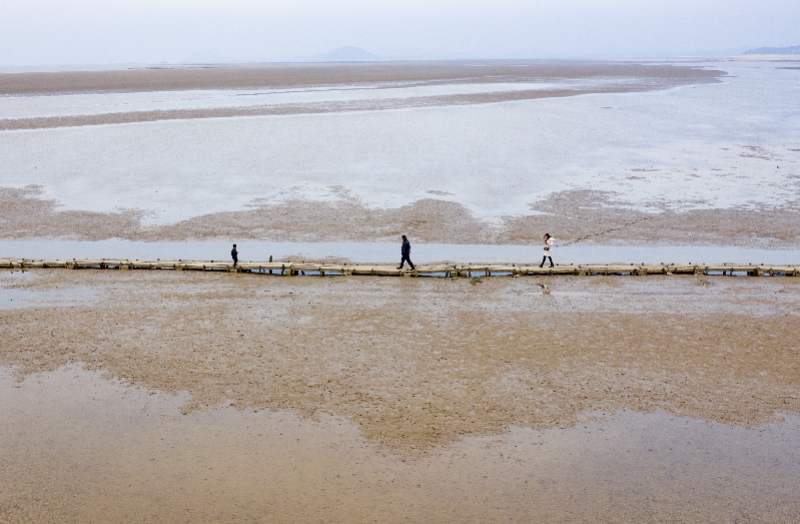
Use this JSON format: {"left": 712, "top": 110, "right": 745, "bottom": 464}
{"left": 0, "top": 270, "right": 800, "bottom": 522}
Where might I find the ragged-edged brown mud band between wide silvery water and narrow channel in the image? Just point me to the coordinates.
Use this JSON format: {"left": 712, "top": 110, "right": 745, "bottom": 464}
{"left": 6, "top": 186, "right": 800, "bottom": 249}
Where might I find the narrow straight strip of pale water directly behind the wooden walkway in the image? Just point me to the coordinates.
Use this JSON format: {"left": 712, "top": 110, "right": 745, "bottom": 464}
{"left": 0, "top": 240, "right": 800, "bottom": 265}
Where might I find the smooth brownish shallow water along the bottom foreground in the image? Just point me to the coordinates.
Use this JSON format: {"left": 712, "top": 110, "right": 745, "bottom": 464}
{"left": 0, "top": 365, "right": 800, "bottom": 522}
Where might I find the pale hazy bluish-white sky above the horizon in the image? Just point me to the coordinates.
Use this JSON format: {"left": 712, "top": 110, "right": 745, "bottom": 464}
{"left": 0, "top": 0, "right": 800, "bottom": 66}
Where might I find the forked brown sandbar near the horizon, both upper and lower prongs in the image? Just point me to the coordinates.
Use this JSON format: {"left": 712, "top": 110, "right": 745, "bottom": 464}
{"left": 0, "top": 60, "right": 724, "bottom": 131}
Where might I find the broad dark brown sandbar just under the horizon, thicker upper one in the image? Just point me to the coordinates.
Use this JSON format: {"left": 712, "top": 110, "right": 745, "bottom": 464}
{"left": 0, "top": 60, "right": 723, "bottom": 96}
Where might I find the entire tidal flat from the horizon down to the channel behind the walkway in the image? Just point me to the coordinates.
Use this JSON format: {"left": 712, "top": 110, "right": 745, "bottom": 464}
{"left": 0, "top": 61, "right": 800, "bottom": 244}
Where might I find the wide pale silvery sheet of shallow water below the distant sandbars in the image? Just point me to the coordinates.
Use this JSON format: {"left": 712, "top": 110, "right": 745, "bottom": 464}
{"left": 0, "top": 62, "right": 800, "bottom": 223}
